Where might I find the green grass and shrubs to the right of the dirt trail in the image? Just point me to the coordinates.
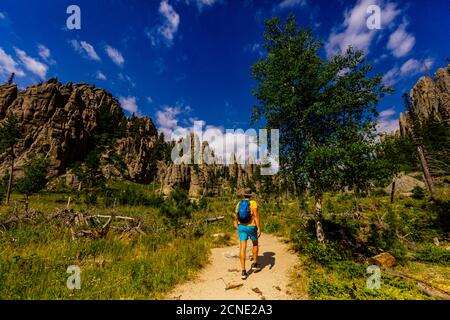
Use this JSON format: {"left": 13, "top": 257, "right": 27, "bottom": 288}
{"left": 262, "top": 189, "right": 450, "bottom": 300}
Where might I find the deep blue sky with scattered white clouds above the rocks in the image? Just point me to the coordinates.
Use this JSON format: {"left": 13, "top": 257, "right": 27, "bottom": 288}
{"left": 0, "top": 0, "right": 450, "bottom": 138}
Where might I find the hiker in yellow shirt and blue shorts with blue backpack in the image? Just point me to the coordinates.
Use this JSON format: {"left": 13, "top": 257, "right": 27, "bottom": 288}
{"left": 235, "top": 188, "right": 261, "bottom": 280}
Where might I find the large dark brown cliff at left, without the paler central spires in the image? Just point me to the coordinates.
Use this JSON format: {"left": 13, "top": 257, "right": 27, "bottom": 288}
{"left": 0, "top": 79, "right": 157, "bottom": 182}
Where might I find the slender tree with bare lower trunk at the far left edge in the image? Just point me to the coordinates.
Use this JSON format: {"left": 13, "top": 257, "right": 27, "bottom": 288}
{"left": 0, "top": 113, "right": 21, "bottom": 204}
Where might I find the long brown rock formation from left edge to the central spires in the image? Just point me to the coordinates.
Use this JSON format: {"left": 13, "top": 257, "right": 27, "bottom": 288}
{"left": 0, "top": 79, "right": 270, "bottom": 197}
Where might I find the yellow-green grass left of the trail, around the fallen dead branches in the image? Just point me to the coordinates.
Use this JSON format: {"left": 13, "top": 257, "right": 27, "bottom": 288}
{"left": 0, "top": 183, "right": 237, "bottom": 299}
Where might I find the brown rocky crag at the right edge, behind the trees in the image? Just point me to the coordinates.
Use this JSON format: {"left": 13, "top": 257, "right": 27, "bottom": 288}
{"left": 399, "top": 65, "right": 450, "bottom": 136}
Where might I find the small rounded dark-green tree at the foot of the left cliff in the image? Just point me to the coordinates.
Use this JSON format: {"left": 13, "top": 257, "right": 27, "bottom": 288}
{"left": 15, "top": 155, "right": 50, "bottom": 200}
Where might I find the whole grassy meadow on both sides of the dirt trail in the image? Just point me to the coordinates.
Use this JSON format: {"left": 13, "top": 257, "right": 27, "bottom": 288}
{"left": 0, "top": 181, "right": 450, "bottom": 299}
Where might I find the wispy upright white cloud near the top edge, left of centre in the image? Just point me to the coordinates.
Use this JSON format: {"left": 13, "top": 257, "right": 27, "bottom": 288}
{"left": 147, "top": 0, "right": 180, "bottom": 47}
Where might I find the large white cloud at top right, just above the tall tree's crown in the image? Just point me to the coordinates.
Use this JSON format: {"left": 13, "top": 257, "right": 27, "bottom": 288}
{"left": 325, "top": 0, "right": 400, "bottom": 58}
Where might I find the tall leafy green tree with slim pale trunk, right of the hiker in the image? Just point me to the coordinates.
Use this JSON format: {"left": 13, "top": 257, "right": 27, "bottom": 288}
{"left": 252, "top": 15, "right": 391, "bottom": 242}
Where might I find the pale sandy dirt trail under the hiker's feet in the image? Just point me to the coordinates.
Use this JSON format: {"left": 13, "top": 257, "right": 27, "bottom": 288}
{"left": 168, "top": 233, "right": 298, "bottom": 300}
